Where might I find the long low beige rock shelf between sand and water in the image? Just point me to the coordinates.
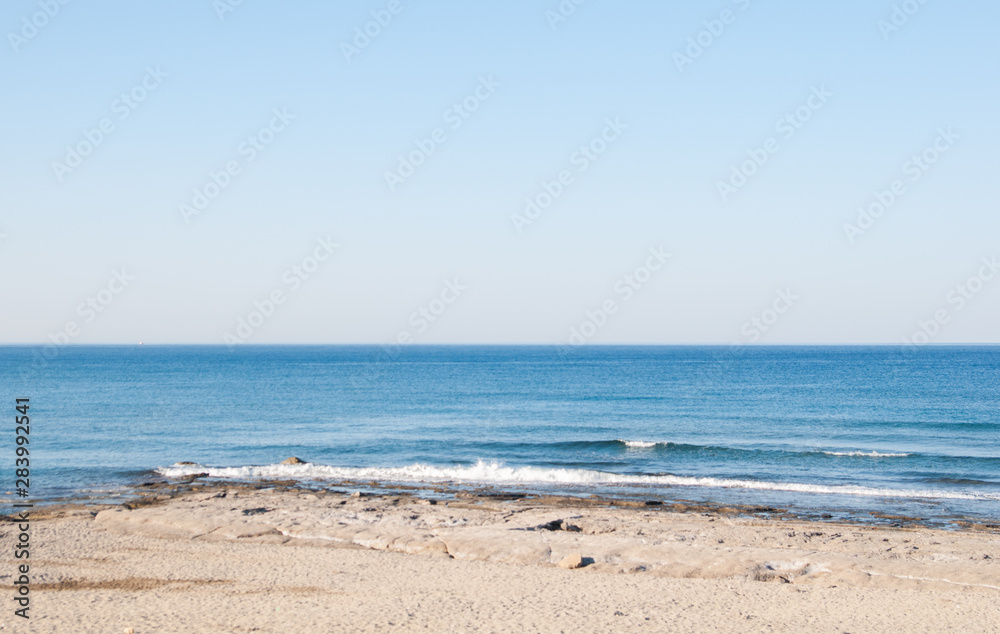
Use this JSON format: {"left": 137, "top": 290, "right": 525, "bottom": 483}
{"left": 95, "top": 486, "right": 1000, "bottom": 589}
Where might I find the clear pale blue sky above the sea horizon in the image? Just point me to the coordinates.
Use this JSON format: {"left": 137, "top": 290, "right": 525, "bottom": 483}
{"left": 0, "top": 0, "right": 1000, "bottom": 346}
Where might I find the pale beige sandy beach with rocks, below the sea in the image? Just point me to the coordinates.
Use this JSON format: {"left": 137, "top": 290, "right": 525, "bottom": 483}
{"left": 0, "top": 485, "right": 1000, "bottom": 633}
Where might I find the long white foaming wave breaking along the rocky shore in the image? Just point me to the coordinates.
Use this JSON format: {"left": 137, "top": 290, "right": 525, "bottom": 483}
{"left": 157, "top": 460, "right": 1000, "bottom": 501}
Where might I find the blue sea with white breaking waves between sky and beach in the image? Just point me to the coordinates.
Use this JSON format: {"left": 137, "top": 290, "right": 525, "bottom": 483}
{"left": 0, "top": 346, "right": 1000, "bottom": 525}
